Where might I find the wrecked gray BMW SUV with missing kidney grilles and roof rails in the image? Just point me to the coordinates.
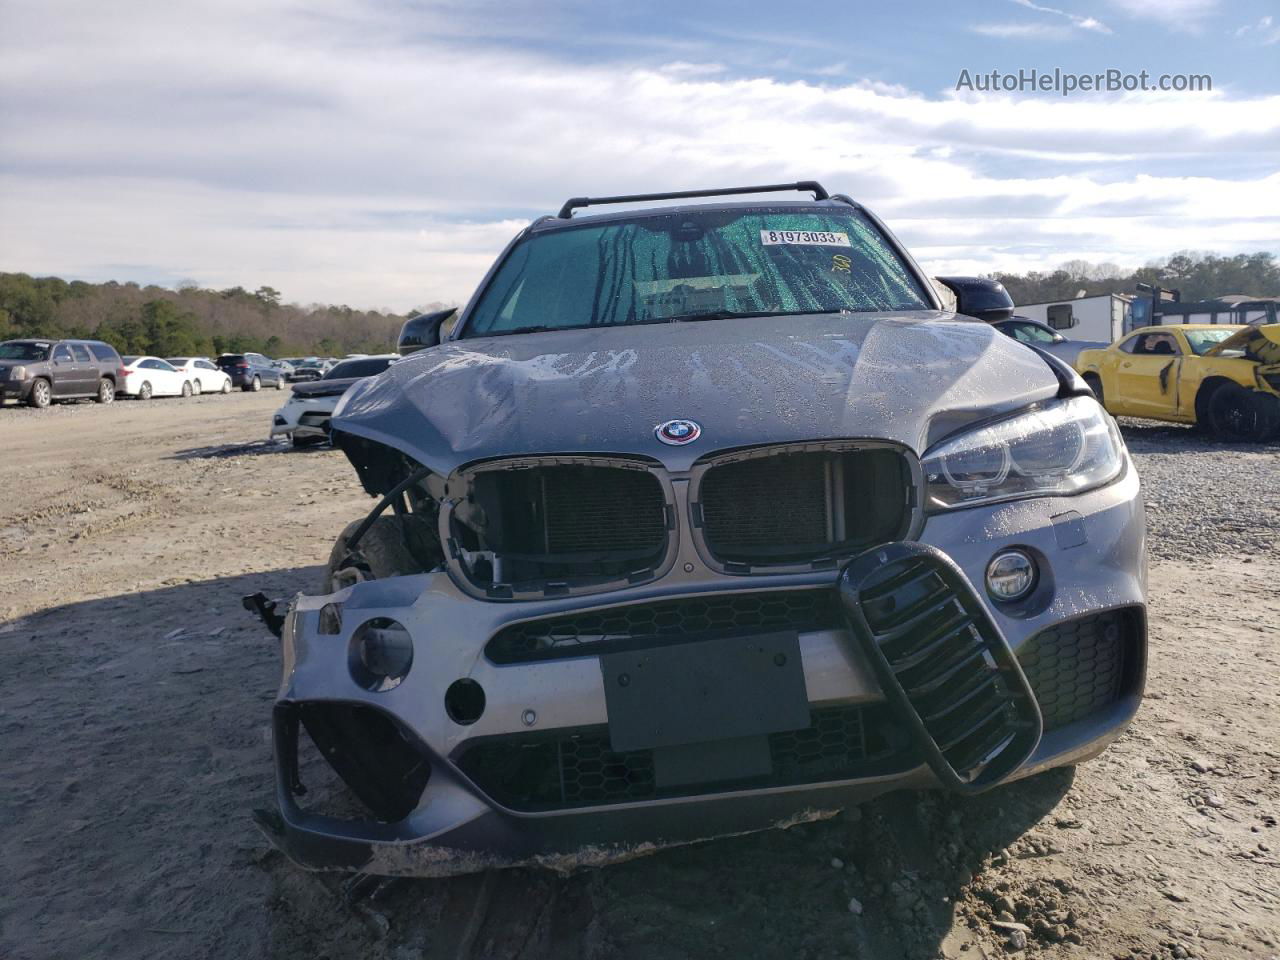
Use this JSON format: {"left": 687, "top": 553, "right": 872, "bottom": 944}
{"left": 250, "top": 182, "right": 1147, "bottom": 876}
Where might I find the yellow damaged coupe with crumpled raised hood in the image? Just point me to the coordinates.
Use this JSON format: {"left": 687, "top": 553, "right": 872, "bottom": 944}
{"left": 1075, "top": 324, "right": 1280, "bottom": 442}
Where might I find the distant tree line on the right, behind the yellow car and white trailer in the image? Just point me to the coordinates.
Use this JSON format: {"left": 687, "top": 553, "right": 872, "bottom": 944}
{"left": 992, "top": 251, "right": 1280, "bottom": 303}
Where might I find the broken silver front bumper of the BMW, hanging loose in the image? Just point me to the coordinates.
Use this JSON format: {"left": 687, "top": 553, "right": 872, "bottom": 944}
{"left": 260, "top": 467, "right": 1146, "bottom": 877}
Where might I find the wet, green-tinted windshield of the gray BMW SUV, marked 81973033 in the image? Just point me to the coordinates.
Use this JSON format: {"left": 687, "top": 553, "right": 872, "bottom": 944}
{"left": 462, "top": 207, "right": 931, "bottom": 337}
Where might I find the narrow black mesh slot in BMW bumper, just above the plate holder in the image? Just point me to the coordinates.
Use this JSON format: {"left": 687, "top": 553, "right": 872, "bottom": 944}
{"left": 485, "top": 588, "right": 844, "bottom": 663}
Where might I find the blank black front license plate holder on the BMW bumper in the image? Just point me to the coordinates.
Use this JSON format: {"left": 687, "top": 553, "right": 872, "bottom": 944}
{"left": 600, "top": 631, "right": 809, "bottom": 753}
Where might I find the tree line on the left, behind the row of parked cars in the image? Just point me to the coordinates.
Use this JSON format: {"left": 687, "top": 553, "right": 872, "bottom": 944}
{"left": 0, "top": 273, "right": 458, "bottom": 357}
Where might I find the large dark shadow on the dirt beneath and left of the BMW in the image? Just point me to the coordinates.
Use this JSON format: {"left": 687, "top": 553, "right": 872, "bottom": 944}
{"left": 0, "top": 567, "right": 1071, "bottom": 960}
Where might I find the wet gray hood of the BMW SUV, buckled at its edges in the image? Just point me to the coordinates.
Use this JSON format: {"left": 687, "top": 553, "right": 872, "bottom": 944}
{"left": 333, "top": 311, "right": 1059, "bottom": 474}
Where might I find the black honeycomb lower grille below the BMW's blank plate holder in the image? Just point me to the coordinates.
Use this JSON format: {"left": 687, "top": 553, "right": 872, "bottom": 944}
{"left": 454, "top": 705, "right": 919, "bottom": 810}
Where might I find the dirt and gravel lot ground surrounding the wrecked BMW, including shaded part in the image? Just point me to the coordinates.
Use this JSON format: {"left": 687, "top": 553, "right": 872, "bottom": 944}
{"left": 0, "top": 392, "right": 1280, "bottom": 960}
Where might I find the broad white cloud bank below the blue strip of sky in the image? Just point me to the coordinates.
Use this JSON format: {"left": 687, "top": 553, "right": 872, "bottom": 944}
{"left": 0, "top": 0, "right": 1280, "bottom": 308}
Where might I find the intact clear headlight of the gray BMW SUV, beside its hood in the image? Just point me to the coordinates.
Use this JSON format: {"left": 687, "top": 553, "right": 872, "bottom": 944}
{"left": 923, "top": 397, "right": 1124, "bottom": 509}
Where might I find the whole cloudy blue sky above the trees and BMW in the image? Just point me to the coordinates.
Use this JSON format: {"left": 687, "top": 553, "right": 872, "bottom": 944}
{"left": 0, "top": 0, "right": 1280, "bottom": 311}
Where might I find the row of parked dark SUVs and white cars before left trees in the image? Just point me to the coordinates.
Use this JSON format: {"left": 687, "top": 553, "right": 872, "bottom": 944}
{"left": 0, "top": 338, "right": 288, "bottom": 407}
